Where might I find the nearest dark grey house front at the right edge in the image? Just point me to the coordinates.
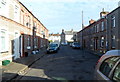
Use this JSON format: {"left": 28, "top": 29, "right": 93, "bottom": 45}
{"left": 107, "top": 7, "right": 120, "bottom": 50}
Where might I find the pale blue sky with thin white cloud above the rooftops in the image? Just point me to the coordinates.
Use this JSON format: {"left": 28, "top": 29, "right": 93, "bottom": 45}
{"left": 19, "top": 0, "right": 120, "bottom": 33}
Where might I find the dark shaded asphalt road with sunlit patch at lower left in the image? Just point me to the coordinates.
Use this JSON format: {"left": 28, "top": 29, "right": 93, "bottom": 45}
{"left": 16, "top": 46, "right": 99, "bottom": 80}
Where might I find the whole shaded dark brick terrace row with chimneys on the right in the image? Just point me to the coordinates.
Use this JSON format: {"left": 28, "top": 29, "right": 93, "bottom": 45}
{"left": 77, "top": 7, "right": 120, "bottom": 53}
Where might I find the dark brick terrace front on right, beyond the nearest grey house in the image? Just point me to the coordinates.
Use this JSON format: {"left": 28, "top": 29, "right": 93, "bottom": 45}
{"left": 78, "top": 18, "right": 106, "bottom": 51}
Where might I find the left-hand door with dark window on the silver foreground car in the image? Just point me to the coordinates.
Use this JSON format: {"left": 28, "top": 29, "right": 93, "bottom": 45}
{"left": 97, "top": 57, "right": 120, "bottom": 81}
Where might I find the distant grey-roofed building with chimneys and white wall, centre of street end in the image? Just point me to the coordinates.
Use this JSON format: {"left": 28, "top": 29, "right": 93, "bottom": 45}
{"left": 61, "top": 29, "right": 77, "bottom": 43}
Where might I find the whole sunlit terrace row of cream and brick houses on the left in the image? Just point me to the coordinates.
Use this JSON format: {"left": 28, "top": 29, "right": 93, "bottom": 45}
{"left": 0, "top": 0, "right": 49, "bottom": 65}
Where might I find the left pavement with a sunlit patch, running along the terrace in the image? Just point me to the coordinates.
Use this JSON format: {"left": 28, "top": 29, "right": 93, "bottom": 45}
{"left": 1, "top": 50, "right": 45, "bottom": 82}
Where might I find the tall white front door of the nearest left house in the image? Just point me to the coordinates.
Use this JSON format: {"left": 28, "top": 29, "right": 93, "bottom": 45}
{"left": 14, "top": 32, "right": 20, "bottom": 59}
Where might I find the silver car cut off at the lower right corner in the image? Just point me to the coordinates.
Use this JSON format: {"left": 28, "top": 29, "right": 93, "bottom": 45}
{"left": 94, "top": 50, "right": 120, "bottom": 82}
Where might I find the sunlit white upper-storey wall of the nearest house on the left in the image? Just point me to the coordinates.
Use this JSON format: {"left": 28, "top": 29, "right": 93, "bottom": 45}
{"left": 0, "top": 0, "right": 20, "bottom": 23}
